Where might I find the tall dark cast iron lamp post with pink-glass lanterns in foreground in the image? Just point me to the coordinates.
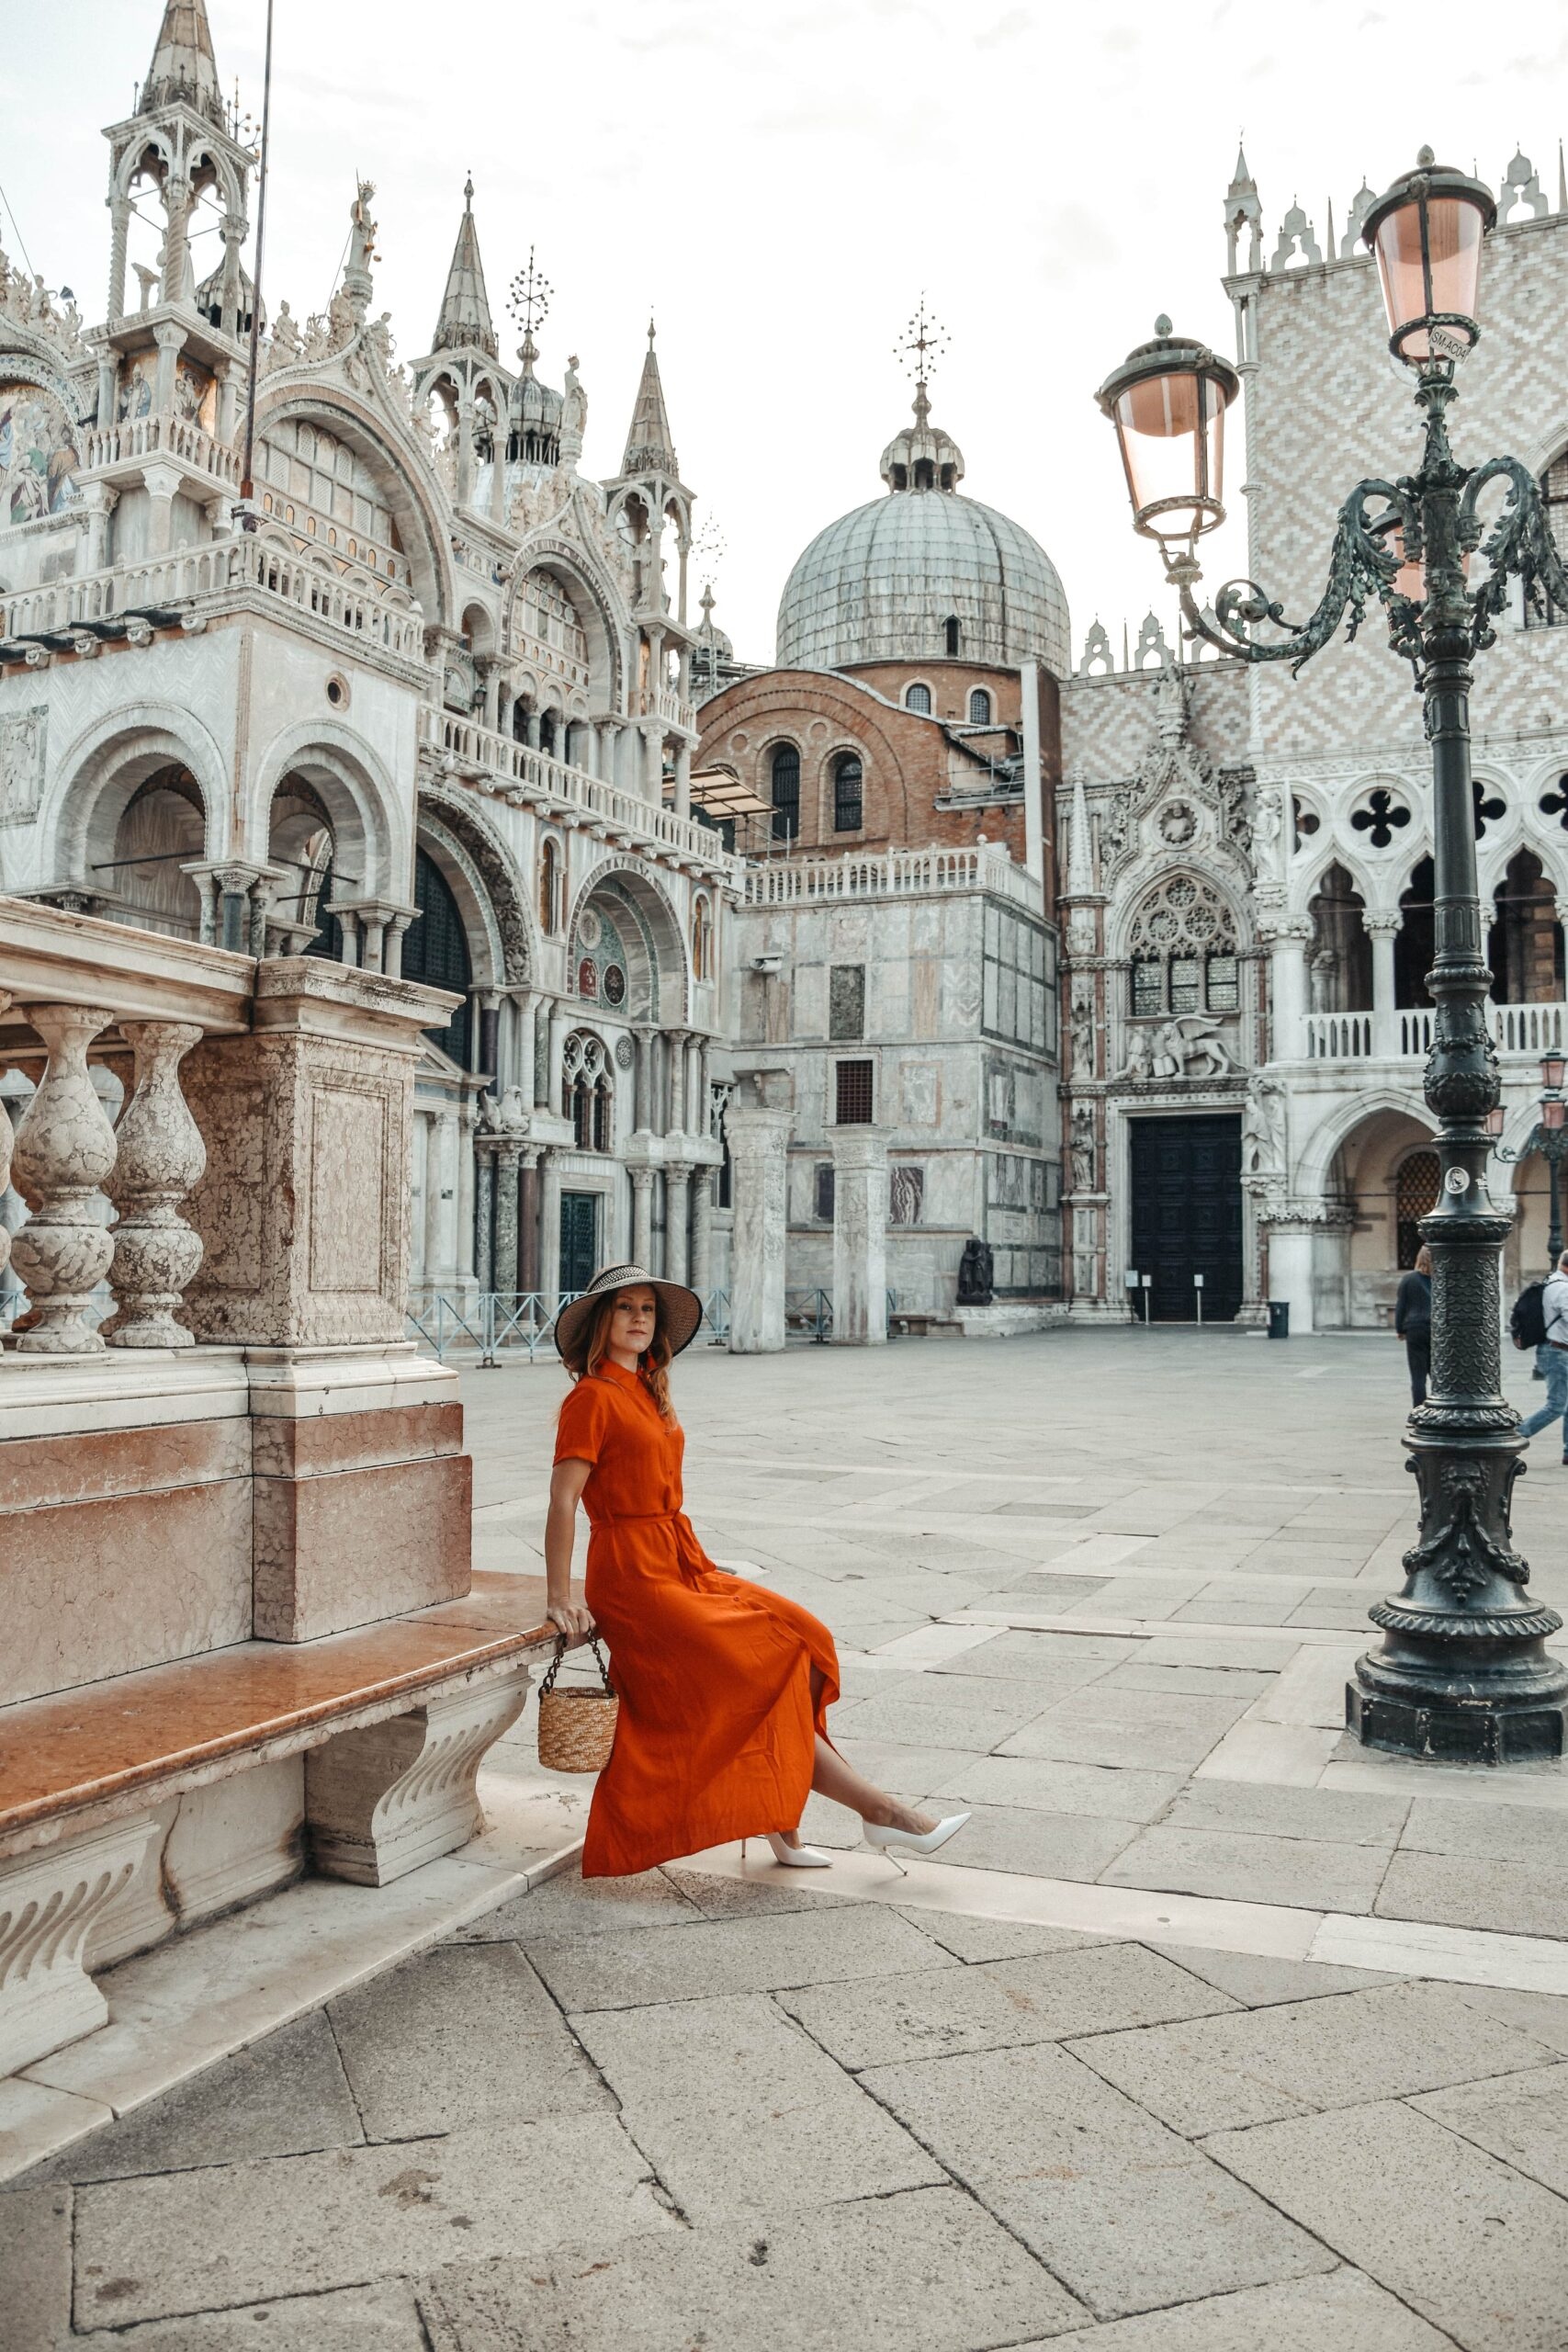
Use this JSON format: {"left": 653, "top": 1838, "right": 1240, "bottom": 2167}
{"left": 1098, "top": 148, "right": 1568, "bottom": 1764}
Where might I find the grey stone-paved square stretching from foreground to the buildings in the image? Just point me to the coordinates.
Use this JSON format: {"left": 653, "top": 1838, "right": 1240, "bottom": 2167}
{"left": 0, "top": 1331, "right": 1568, "bottom": 2352}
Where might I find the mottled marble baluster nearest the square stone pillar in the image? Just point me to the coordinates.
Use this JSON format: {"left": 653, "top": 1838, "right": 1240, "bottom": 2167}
{"left": 104, "top": 1021, "right": 207, "bottom": 1348}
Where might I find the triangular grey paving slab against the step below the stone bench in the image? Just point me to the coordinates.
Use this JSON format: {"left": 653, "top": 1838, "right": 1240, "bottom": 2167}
{"left": 20, "top": 2008, "right": 365, "bottom": 2182}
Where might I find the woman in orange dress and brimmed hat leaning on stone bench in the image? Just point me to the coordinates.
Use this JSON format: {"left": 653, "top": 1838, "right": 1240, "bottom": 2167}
{"left": 546, "top": 1265, "right": 968, "bottom": 1879}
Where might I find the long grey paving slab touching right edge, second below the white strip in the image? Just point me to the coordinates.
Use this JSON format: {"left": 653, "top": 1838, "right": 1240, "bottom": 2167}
{"left": 1072, "top": 1985, "right": 1554, "bottom": 2138}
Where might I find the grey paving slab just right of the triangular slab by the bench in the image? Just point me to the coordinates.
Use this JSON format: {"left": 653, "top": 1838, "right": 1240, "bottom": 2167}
{"left": 329, "top": 1943, "right": 611, "bottom": 2141}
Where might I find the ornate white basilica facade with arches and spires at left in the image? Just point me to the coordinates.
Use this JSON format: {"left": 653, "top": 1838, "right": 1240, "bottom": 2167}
{"left": 0, "top": 0, "right": 736, "bottom": 1301}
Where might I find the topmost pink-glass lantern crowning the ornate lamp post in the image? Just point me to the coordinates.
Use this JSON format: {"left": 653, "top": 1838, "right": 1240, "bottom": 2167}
{"left": 1361, "top": 148, "right": 1497, "bottom": 367}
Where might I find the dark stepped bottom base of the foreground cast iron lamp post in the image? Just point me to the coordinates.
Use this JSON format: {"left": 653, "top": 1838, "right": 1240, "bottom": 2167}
{"left": 1345, "top": 1636, "right": 1568, "bottom": 1764}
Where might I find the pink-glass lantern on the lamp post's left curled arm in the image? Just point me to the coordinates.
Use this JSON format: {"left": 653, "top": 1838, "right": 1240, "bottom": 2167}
{"left": 1096, "top": 318, "right": 1241, "bottom": 570}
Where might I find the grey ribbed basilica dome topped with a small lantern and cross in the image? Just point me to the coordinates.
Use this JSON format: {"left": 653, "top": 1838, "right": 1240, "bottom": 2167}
{"left": 776, "top": 383, "right": 1072, "bottom": 677}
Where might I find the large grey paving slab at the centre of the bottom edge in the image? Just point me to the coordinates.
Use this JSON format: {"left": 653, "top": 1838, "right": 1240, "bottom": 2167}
{"left": 411, "top": 2189, "right": 1089, "bottom": 2352}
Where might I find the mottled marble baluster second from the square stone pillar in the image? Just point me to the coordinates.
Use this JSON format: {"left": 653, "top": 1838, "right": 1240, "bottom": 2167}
{"left": 12, "top": 1004, "right": 115, "bottom": 1355}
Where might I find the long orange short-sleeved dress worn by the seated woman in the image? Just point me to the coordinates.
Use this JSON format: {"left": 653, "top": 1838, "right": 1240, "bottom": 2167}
{"left": 555, "top": 1362, "right": 840, "bottom": 1879}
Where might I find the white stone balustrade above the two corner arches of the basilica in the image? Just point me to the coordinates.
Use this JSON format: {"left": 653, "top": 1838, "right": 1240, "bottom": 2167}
{"left": 0, "top": 534, "right": 428, "bottom": 677}
